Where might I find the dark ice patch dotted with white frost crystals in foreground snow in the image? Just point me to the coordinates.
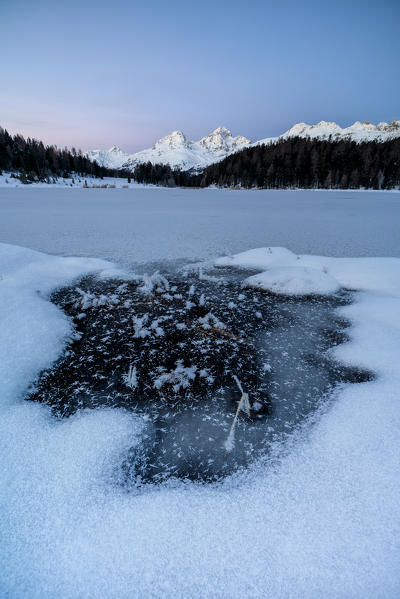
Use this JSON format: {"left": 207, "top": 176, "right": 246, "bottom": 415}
{"left": 28, "top": 269, "right": 369, "bottom": 486}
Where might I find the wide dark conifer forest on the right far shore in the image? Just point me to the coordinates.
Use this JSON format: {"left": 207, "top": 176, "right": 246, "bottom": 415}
{"left": 133, "top": 137, "right": 400, "bottom": 189}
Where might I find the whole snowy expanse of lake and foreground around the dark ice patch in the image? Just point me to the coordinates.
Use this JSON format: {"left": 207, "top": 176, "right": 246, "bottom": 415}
{"left": 0, "top": 189, "right": 400, "bottom": 599}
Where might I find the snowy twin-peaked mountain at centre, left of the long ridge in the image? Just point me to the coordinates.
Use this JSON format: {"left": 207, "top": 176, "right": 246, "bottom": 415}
{"left": 87, "top": 127, "right": 251, "bottom": 170}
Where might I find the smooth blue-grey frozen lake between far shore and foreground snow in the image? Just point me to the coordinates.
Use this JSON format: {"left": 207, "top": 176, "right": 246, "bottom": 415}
{"left": 0, "top": 187, "right": 400, "bottom": 265}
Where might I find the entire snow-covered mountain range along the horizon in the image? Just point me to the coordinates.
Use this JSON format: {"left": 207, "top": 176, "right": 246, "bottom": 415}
{"left": 86, "top": 121, "right": 400, "bottom": 171}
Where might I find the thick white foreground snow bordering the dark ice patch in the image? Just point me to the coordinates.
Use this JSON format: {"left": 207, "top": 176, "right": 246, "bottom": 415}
{"left": 0, "top": 245, "right": 400, "bottom": 599}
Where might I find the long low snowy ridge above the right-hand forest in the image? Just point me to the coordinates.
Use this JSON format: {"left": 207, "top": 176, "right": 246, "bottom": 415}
{"left": 253, "top": 121, "right": 400, "bottom": 145}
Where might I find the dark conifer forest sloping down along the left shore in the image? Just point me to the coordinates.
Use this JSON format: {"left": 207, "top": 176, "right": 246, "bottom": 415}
{"left": 0, "top": 127, "right": 132, "bottom": 183}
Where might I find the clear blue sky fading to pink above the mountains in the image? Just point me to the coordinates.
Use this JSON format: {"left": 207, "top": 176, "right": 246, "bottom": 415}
{"left": 0, "top": 0, "right": 400, "bottom": 152}
